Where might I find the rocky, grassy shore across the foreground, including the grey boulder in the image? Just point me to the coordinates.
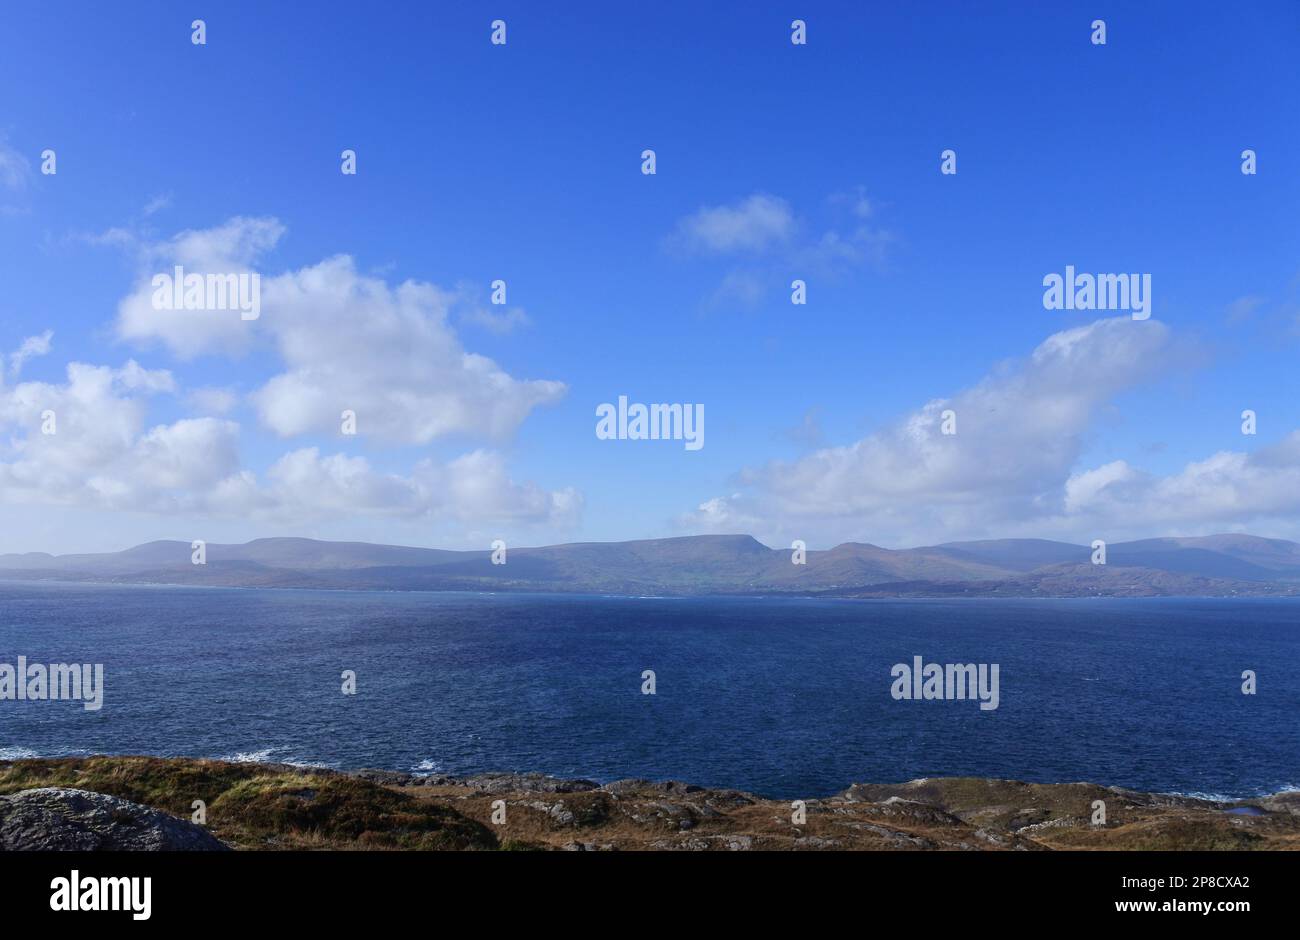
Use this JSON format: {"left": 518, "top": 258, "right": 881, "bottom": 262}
{"left": 0, "top": 757, "right": 1300, "bottom": 852}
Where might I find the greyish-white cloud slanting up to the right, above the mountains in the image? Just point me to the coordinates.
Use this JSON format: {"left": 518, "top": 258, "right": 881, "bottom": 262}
{"left": 681, "top": 317, "right": 1206, "bottom": 543}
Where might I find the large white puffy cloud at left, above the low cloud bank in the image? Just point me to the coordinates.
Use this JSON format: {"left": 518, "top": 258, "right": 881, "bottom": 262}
{"left": 117, "top": 218, "right": 566, "bottom": 443}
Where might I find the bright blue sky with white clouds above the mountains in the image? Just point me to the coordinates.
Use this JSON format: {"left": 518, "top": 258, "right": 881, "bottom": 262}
{"left": 0, "top": 1, "right": 1300, "bottom": 551}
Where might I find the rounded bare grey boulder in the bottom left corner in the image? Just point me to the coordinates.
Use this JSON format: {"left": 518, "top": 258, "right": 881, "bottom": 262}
{"left": 0, "top": 787, "right": 228, "bottom": 852}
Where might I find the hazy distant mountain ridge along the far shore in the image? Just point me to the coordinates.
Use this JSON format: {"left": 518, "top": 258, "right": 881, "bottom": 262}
{"left": 0, "top": 534, "right": 1300, "bottom": 597}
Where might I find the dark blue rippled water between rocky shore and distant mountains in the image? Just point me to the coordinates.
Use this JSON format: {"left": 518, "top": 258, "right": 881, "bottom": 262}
{"left": 0, "top": 584, "right": 1300, "bottom": 797}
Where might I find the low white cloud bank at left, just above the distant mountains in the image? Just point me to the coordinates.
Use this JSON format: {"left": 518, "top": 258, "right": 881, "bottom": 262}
{"left": 0, "top": 361, "right": 582, "bottom": 527}
